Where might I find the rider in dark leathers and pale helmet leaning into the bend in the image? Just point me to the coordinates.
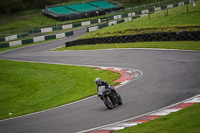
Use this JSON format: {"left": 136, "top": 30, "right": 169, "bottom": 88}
{"left": 95, "top": 78, "right": 116, "bottom": 96}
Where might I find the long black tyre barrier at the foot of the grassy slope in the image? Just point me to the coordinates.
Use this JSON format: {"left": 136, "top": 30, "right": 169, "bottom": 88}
{"left": 65, "top": 31, "right": 200, "bottom": 47}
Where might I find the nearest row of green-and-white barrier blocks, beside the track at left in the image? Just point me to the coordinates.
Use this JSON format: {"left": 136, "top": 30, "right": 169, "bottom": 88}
{"left": 0, "top": 31, "right": 73, "bottom": 48}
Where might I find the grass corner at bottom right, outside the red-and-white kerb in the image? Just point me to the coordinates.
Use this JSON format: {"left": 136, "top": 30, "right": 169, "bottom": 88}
{"left": 115, "top": 104, "right": 200, "bottom": 133}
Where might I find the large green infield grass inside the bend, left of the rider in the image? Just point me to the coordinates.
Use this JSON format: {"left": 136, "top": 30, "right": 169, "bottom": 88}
{"left": 0, "top": 60, "right": 120, "bottom": 119}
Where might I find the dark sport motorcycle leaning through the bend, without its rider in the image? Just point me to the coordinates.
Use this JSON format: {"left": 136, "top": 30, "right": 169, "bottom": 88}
{"left": 98, "top": 86, "right": 123, "bottom": 109}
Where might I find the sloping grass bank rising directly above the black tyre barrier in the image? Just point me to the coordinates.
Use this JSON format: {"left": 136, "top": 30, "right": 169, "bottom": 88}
{"left": 79, "top": 1, "right": 200, "bottom": 39}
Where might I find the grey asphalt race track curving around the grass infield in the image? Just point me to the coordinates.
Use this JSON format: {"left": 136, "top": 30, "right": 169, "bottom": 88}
{"left": 0, "top": 28, "right": 200, "bottom": 133}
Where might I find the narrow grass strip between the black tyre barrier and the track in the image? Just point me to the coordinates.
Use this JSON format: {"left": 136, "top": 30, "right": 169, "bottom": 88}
{"left": 52, "top": 41, "right": 200, "bottom": 51}
